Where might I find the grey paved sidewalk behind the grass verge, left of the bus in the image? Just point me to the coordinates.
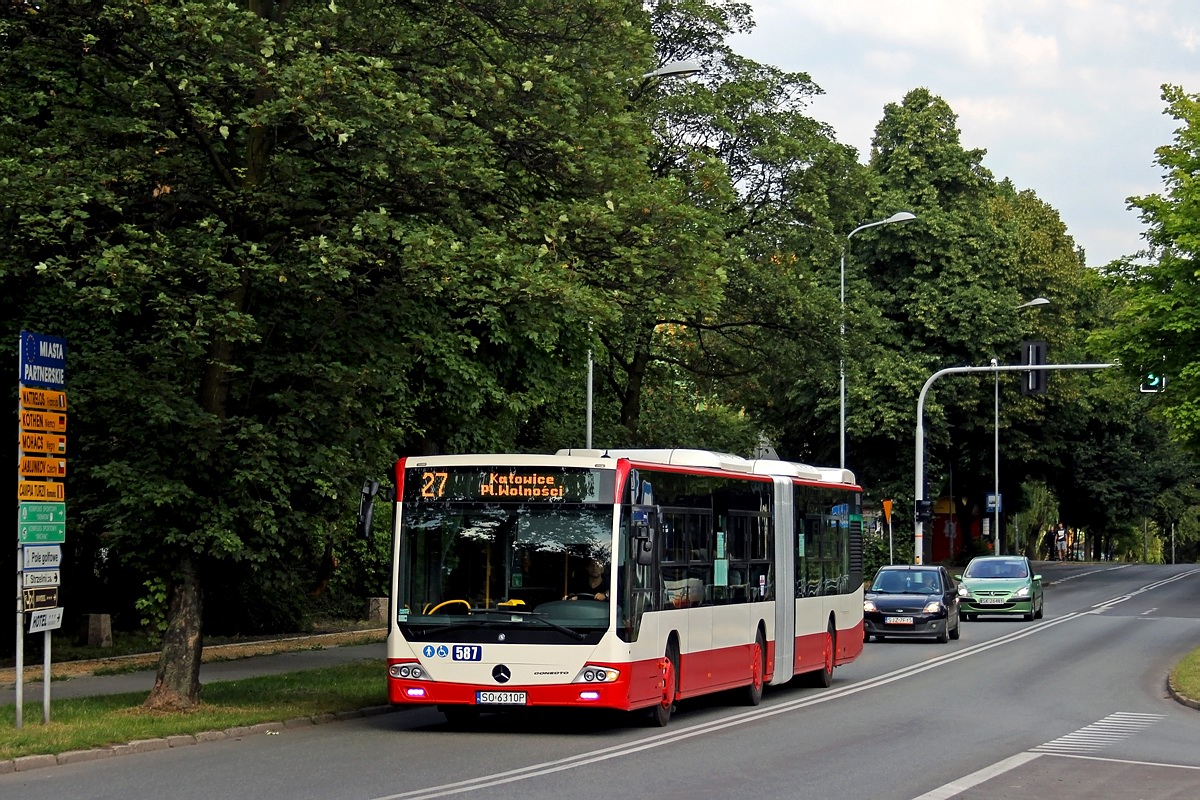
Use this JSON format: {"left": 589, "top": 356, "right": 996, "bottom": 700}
{"left": 0, "top": 642, "right": 386, "bottom": 705}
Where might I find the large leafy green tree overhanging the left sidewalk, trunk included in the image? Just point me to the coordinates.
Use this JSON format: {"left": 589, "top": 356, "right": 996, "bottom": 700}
{"left": 0, "top": 0, "right": 649, "bottom": 708}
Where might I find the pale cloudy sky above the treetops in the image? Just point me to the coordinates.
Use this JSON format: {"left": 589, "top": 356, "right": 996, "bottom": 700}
{"left": 728, "top": 0, "right": 1200, "bottom": 266}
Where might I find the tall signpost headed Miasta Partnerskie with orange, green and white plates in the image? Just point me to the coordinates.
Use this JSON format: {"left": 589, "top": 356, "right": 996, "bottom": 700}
{"left": 16, "top": 331, "right": 67, "bottom": 728}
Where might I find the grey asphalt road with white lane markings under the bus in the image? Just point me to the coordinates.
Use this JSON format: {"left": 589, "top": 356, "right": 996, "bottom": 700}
{"left": 0, "top": 564, "right": 1200, "bottom": 800}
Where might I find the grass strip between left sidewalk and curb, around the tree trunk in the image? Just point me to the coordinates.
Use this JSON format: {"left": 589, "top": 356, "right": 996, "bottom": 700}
{"left": 0, "top": 658, "right": 386, "bottom": 760}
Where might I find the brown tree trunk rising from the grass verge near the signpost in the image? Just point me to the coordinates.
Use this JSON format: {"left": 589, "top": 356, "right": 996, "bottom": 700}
{"left": 143, "top": 558, "right": 204, "bottom": 711}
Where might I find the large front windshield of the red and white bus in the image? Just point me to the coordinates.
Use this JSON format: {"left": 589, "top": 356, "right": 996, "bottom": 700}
{"left": 396, "top": 501, "right": 613, "bottom": 642}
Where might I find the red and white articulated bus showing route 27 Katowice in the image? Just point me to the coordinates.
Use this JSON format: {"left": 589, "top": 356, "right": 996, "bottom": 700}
{"left": 360, "top": 450, "right": 863, "bottom": 724}
